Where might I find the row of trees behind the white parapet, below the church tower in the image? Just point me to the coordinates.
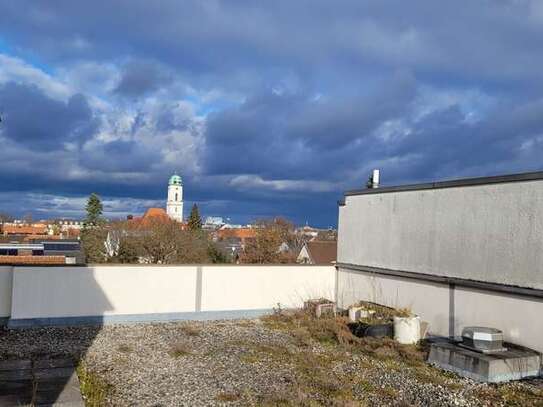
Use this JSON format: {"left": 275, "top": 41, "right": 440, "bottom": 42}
{"left": 81, "top": 194, "right": 305, "bottom": 264}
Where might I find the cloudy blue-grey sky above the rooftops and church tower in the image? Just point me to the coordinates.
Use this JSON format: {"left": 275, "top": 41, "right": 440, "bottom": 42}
{"left": 0, "top": 0, "right": 543, "bottom": 227}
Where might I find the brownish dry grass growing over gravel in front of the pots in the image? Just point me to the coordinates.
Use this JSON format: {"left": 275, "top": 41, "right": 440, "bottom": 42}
{"left": 260, "top": 308, "right": 543, "bottom": 406}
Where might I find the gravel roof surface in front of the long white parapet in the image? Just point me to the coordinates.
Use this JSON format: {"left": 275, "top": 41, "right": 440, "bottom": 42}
{"left": 0, "top": 320, "right": 543, "bottom": 406}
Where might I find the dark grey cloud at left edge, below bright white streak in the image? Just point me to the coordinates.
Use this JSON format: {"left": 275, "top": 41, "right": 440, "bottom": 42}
{"left": 0, "top": 82, "right": 97, "bottom": 150}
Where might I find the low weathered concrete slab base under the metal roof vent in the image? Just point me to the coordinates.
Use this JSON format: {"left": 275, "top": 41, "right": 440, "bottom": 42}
{"left": 428, "top": 342, "right": 541, "bottom": 383}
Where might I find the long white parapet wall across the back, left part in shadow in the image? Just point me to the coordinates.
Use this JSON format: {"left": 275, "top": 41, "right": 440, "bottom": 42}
{"left": 8, "top": 265, "right": 336, "bottom": 327}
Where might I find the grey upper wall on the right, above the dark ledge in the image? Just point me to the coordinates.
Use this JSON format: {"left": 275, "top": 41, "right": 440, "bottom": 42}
{"left": 338, "top": 179, "right": 543, "bottom": 289}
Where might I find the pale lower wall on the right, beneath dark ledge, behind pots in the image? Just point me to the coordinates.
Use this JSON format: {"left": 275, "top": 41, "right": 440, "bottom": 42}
{"left": 337, "top": 267, "right": 543, "bottom": 352}
